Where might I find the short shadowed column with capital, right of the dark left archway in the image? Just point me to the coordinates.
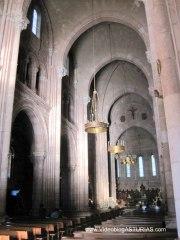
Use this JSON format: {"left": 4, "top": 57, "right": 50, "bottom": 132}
{"left": 32, "top": 153, "right": 45, "bottom": 215}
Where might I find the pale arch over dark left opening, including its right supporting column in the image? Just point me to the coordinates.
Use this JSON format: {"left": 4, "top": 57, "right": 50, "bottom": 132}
{"left": 12, "top": 99, "right": 48, "bottom": 215}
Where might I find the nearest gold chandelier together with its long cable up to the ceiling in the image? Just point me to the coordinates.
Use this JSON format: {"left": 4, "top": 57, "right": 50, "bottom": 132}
{"left": 85, "top": 0, "right": 108, "bottom": 134}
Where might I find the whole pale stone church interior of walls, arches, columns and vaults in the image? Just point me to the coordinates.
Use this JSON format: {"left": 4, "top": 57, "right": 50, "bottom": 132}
{"left": 0, "top": 0, "right": 180, "bottom": 237}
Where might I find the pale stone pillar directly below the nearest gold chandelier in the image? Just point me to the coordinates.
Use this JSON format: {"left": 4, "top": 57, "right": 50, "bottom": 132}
{"left": 95, "top": 132, "right": 109, "bottom": 210}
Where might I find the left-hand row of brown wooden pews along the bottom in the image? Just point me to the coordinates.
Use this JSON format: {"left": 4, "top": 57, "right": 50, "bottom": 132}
{"left": 0, "top": 209, "right": 122, "bottom": 240}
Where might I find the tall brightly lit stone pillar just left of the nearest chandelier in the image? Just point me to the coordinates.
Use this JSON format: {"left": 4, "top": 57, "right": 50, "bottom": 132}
{"left": 71, "top": 95, "right": 89, "bottom": 215}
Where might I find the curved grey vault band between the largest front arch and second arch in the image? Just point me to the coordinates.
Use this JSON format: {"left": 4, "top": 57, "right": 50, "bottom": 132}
{"left": 68, "top": 22, "right": 152, "bottom": 99}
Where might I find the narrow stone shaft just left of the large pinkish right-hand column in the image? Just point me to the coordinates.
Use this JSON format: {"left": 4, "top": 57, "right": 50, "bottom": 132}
{"left": 150, "top": 86, "right": 176, "bottom": 219}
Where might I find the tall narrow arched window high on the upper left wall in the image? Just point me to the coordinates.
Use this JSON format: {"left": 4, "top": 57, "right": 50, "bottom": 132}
{"left": 31, "top": 8, "right": 41, "bottom": 38}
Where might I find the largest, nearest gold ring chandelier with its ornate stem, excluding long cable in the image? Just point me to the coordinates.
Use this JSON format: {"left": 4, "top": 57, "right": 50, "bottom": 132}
{"left": 85, "top": 89, "right": 108, "bottom": 134}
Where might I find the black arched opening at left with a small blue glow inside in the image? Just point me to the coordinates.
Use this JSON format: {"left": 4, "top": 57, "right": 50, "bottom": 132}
{"left": 6, "top": 111, "right": 34, "bottom": 216}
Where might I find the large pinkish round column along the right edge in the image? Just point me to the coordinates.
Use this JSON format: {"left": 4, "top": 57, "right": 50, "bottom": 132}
{"left": 145, "top": 0, "right": 180, "bottom": 233}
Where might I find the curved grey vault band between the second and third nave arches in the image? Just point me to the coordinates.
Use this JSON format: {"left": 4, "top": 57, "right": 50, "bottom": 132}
{"left": 89, "top": 59, "right": 153, "bottom": 121}
